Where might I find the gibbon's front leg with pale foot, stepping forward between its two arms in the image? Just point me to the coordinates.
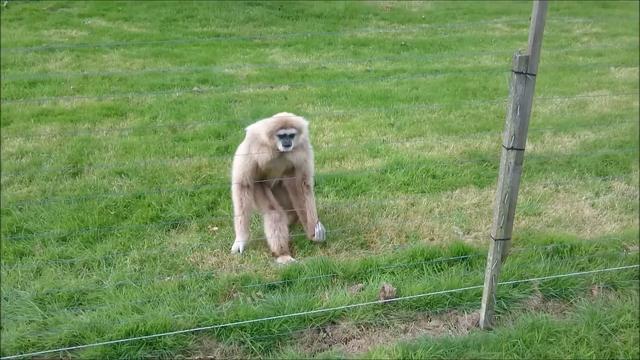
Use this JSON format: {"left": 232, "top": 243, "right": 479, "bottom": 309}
{"left": 255, "top": 183, "right": 295, "bottom": 264}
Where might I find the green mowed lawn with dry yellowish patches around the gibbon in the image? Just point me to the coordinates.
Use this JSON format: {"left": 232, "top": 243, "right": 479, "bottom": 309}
{"left": 0, "top": 1, "right": 640, "bottom": 359}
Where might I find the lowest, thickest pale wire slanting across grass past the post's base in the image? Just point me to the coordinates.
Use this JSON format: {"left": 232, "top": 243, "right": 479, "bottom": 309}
{"left": 0, "top": 265, "right": 640, "bottom": 359}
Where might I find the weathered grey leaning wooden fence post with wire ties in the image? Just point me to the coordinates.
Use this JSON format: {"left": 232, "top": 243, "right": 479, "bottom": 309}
{"left": 480, "top": 0, "right": 547, "bottom": 329}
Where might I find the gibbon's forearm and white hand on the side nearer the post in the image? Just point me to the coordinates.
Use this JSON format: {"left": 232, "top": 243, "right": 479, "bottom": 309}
{"left": 284, "top": 173, "right": 326, "bottom": 241}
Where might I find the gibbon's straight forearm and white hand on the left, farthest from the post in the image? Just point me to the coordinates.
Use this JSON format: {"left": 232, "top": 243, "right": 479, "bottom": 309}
{"left": 231, "top": 183, "right": 255, "bottom": 253}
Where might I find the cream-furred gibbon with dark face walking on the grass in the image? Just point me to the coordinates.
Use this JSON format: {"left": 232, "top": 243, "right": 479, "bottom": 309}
{"left": 231, "top": 113, "right": 326, "bottom": 263}
